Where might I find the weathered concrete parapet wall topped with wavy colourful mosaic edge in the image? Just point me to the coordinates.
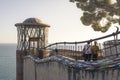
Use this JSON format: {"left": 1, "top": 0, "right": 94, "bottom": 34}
{"left": 23, "top": 56, "right": 120, "bottom": 80}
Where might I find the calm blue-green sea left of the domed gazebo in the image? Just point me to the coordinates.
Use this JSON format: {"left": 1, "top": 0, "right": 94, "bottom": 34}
{"left": 0, "top": 44, "right": 16, "bottom": 80}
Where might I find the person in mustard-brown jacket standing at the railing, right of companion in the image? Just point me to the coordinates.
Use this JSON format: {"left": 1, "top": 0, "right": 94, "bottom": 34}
{"left": 92, "top": 41, "right": 100, "bottom": 61}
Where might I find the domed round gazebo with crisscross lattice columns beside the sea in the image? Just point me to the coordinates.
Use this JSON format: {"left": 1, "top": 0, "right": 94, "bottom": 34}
{"left": 15, "top": 18, "right": 50, "bottom": 80}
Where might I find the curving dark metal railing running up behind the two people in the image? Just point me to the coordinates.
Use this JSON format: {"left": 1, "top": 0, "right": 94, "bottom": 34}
{"left": 44, "top": 31, "right": 120, "bottom": 59}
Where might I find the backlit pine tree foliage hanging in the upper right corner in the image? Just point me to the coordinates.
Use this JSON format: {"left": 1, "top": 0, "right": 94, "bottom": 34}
{"left": 70, "top": 0, "right": 120, "bottom": 32}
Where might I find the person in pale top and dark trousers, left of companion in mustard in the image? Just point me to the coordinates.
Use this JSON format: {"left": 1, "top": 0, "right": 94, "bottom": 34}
{"left": 83, "top": 41, "right": 92, "bottom": 61}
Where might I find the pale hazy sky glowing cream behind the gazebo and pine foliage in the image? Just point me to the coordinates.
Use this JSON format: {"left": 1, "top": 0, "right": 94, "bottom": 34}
{"left": 0, "top": 0, "right": 116, "bottom": 43}
